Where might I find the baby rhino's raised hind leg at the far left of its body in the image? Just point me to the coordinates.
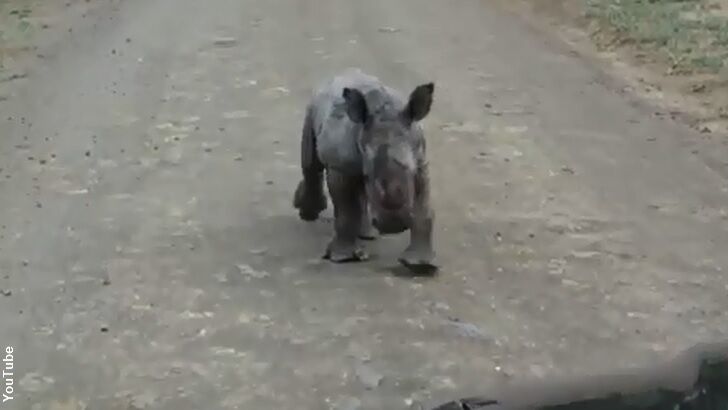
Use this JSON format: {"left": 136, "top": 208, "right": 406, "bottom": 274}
{"left": 293, "top": 108, "right": 327, "bottom": 221}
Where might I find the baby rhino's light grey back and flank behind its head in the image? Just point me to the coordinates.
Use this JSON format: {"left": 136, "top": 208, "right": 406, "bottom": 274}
{"left": 311, "top": 68, "right": 403, "bottom": 174}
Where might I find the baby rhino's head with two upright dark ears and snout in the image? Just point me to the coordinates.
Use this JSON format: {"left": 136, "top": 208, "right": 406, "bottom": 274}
{"left": 343, "top": 83, "right": 435, "bottom": 234}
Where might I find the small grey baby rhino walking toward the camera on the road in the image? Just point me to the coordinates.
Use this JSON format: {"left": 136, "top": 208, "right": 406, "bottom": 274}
{"left": 293, "top": 69, "right": 435, "bottom": 269}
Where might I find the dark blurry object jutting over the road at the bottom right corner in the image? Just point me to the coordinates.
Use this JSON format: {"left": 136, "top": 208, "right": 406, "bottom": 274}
{"left": 433, "top": 342, "right": 728, "bottom": 410}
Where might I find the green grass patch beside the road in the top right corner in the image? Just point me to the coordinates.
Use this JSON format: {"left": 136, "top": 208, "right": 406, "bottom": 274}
{"left": 584, "top": 0, "right": 728, "bottom": 74}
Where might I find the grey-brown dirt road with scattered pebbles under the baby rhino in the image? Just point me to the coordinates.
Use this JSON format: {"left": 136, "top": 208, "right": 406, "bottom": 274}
{"left": 0, "top": 0, "right": 728, "bottom": 410}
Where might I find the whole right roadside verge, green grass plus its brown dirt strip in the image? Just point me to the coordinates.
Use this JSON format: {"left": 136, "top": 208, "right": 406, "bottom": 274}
{"left": 491, "top": 0, "right": 728, "bottom": 135}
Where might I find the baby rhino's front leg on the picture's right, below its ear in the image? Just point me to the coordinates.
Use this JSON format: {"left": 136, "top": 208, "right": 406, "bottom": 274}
{"left": 399, "top": 165, "right": 437, "bottom": 271}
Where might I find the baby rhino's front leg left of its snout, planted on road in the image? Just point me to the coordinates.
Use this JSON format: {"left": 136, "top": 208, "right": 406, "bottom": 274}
{"left": 324, "top": 170, "right": 369, "bottom": 263}
